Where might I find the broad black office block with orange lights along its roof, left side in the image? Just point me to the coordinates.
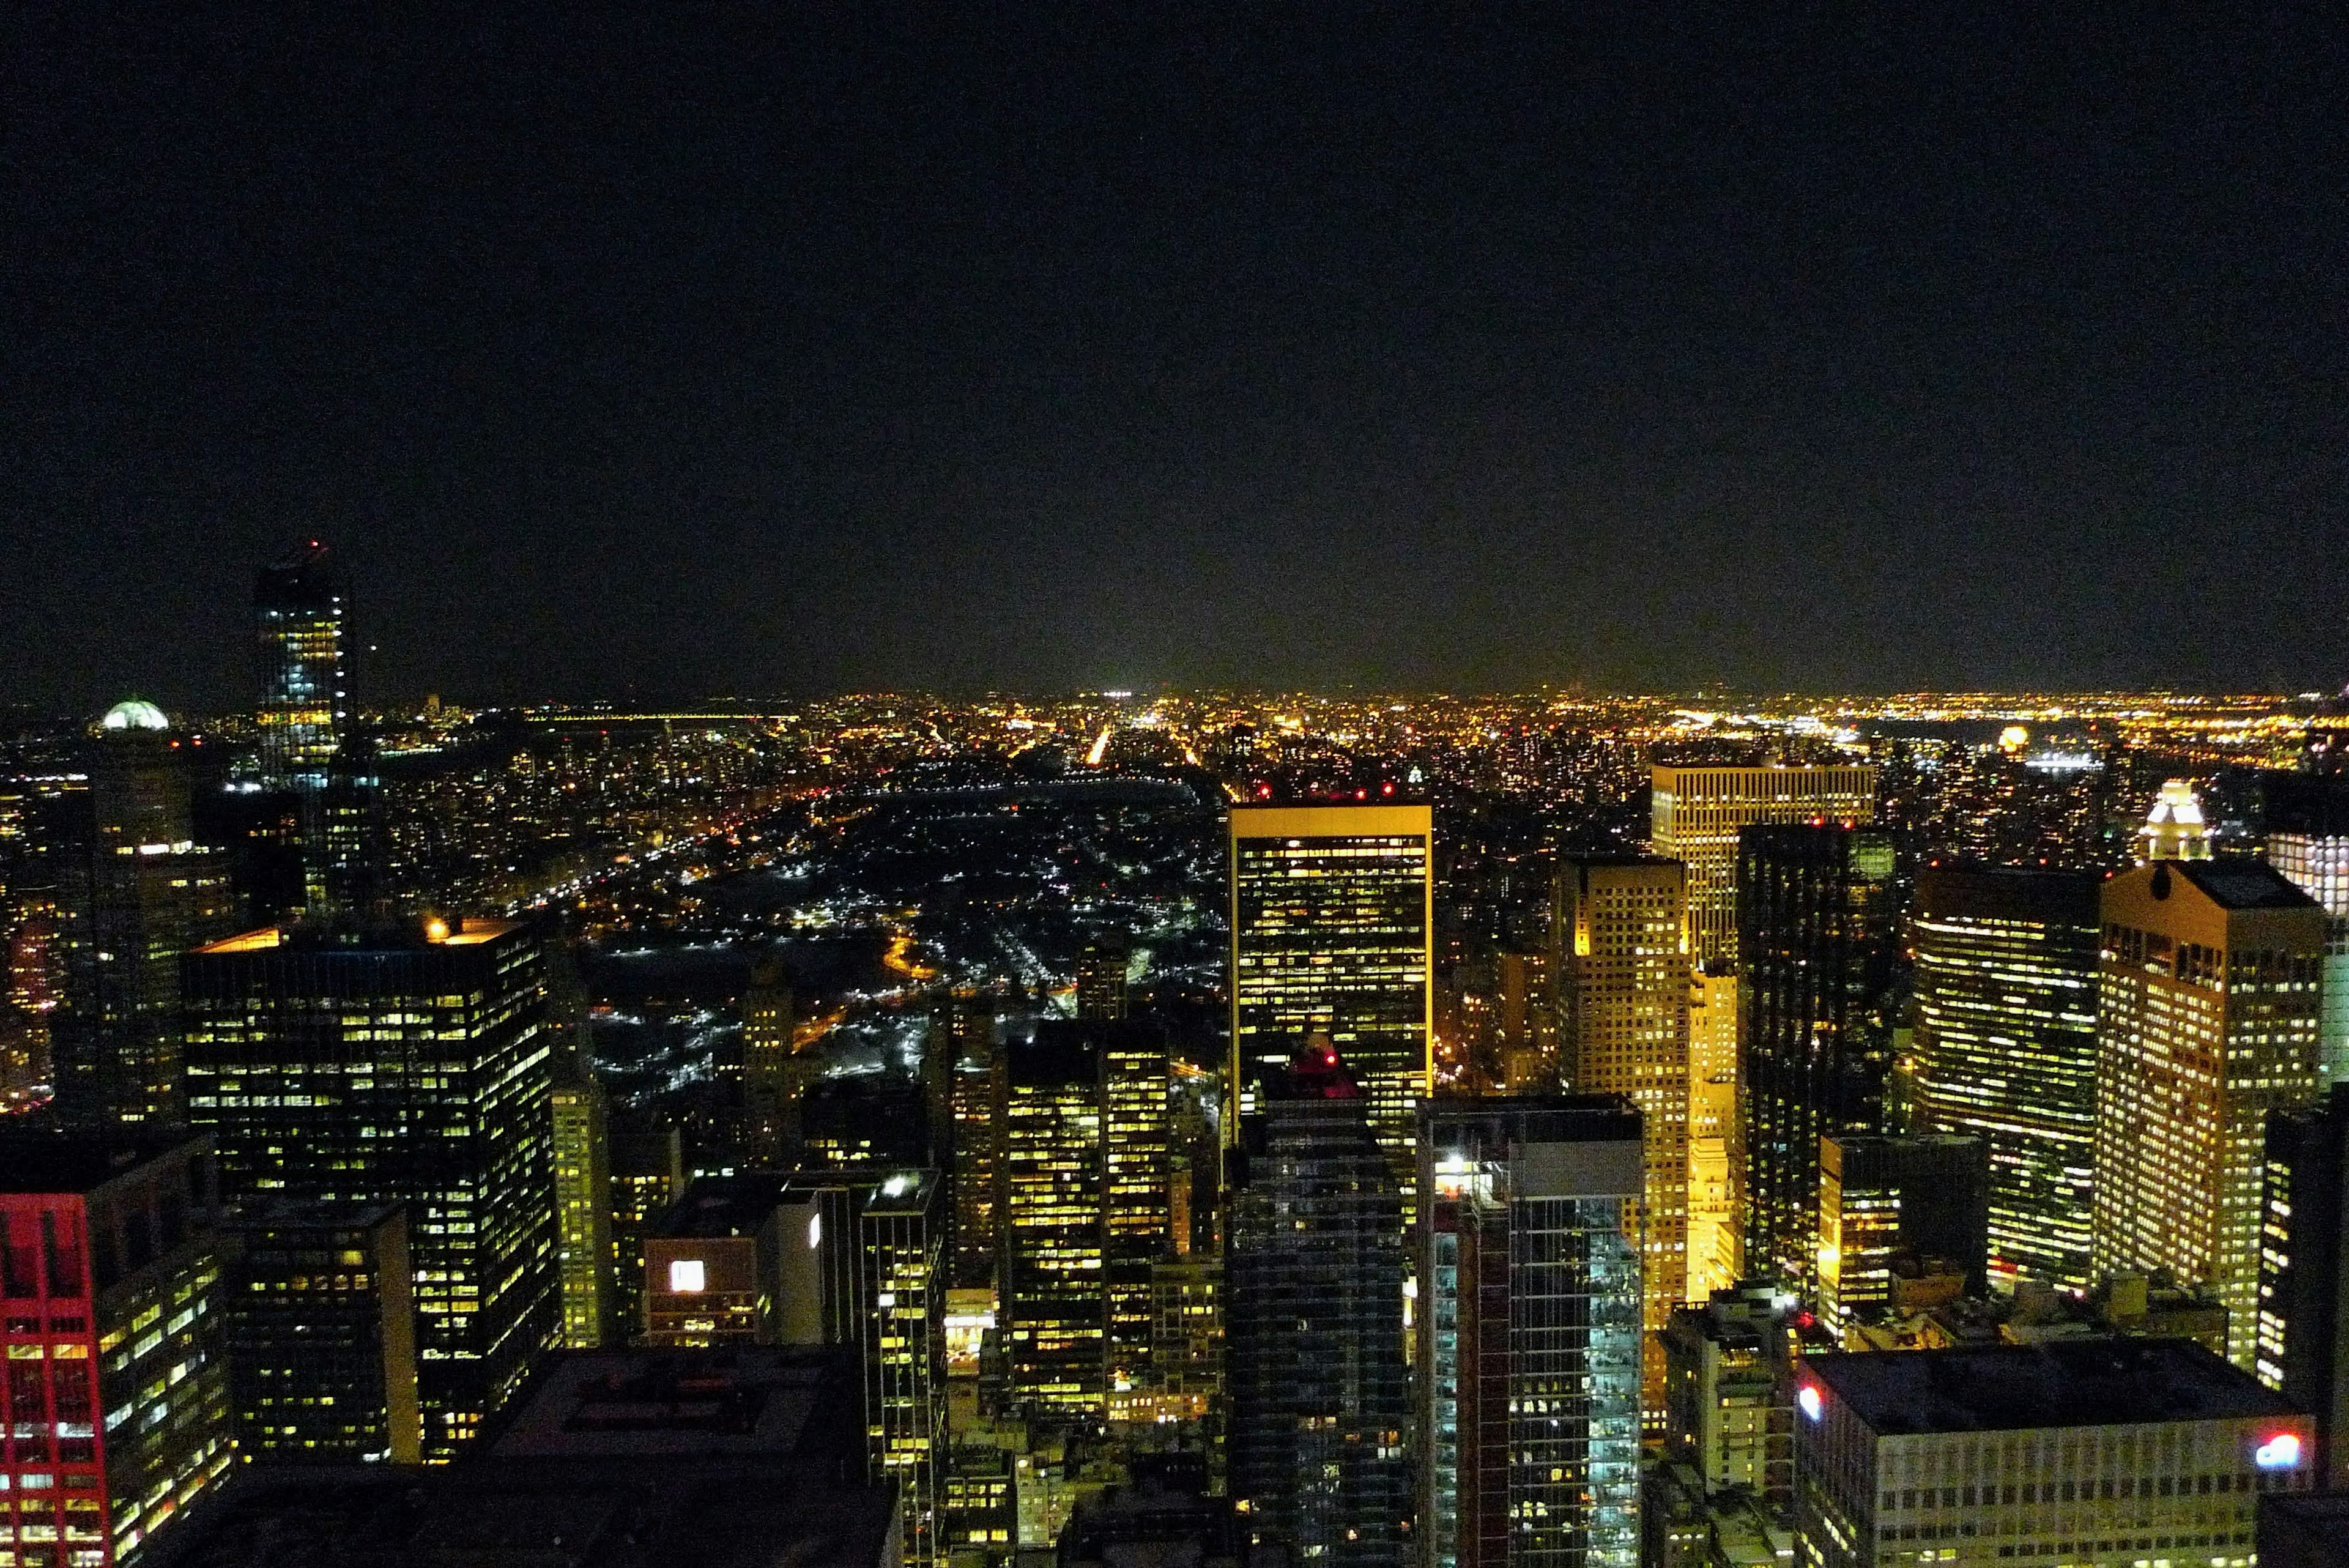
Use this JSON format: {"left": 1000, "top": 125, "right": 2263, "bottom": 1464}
{"left": 184, "top": 919, "right": 562, "bottom": 1460}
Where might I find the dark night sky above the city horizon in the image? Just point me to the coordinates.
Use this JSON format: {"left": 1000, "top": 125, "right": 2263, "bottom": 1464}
{"left": 0, "top": 5, "right": 2349, "bottom": 708}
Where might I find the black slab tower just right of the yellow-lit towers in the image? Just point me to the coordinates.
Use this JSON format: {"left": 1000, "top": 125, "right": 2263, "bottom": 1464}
{"left": 1739, "top": 828, "right": 1901, "bottom": 1293}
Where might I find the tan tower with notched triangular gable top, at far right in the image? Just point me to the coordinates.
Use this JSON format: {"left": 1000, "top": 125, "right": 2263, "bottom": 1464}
{"left": 2091, "top": 860, "right": 2326, "bottom": 1368}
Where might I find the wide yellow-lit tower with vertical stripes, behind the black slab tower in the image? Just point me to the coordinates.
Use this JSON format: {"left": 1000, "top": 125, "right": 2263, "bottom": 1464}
{"left": 1649, "top": 767, "right": 1877, "bottom": 964}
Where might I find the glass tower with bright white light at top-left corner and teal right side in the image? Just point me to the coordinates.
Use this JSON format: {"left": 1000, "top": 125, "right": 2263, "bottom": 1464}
{"left": 1419, "top": 1096, "right": 1647, "bottom": 1568}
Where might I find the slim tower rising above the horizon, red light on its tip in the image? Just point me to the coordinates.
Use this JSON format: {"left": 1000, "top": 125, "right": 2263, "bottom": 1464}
{"left": 254, "top": 538, "right": 347, "bottom": 790}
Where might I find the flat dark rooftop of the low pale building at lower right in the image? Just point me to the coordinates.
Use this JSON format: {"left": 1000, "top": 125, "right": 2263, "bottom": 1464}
{"left": 1804, "top": 1340, "right": 2293, "bottom": 1436}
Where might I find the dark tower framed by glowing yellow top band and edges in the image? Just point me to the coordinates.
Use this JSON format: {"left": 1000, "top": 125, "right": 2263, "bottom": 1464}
{"left": 1226, "top": 806, "right": 1435, "bottom": 1216}
